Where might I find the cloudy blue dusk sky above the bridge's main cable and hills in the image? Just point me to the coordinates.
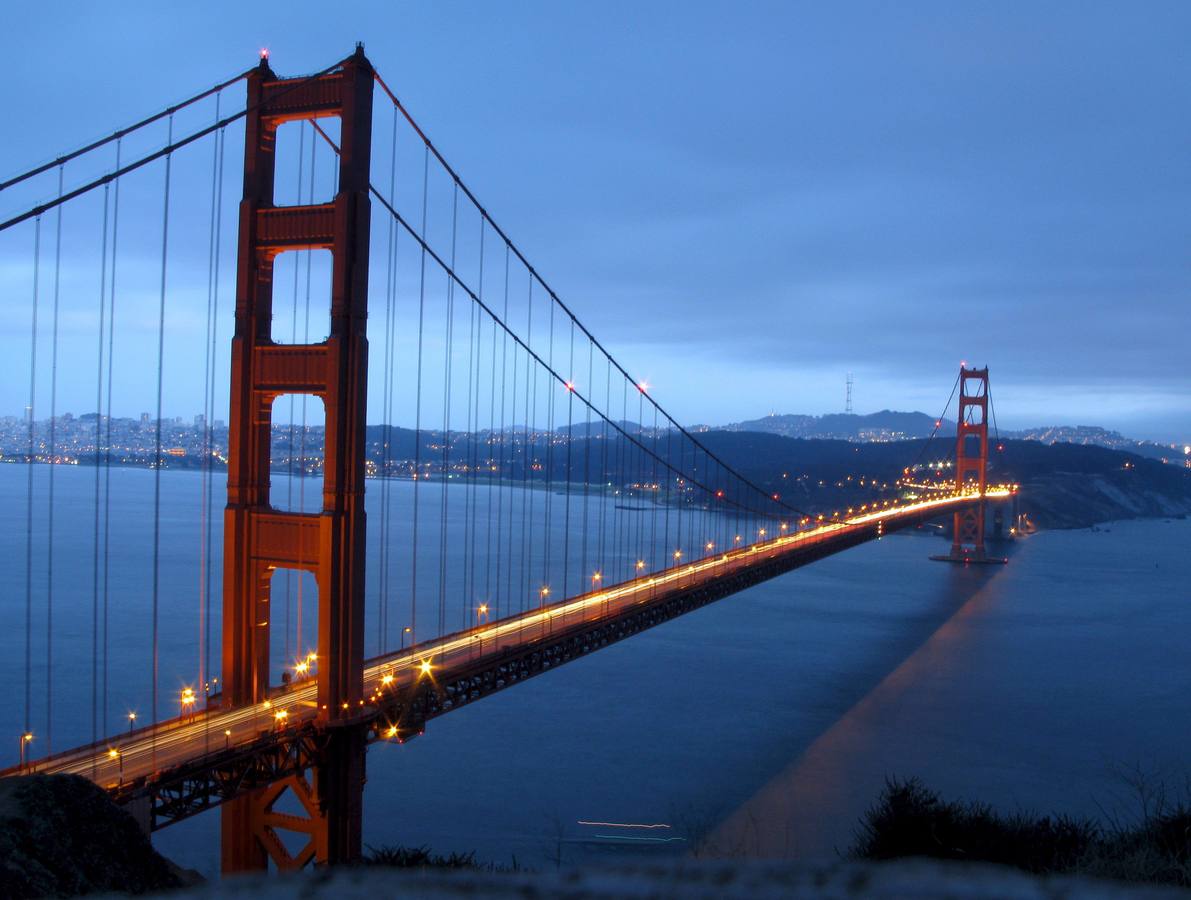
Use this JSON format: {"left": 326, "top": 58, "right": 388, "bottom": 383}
{"left": 0, "top": 2, "right": 1191, "bottom": 439}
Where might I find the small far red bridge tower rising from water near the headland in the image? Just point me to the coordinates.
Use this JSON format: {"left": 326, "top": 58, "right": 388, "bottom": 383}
{"left": 952, "top": 365, "right": 989, "bottom": 561}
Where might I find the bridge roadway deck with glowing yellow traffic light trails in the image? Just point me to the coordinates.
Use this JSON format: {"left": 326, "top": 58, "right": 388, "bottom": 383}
{"left": 0, "top": 488, "right": 1011, "bottom": 826}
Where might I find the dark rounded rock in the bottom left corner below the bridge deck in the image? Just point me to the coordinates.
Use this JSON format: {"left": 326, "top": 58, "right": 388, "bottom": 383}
{"left": 0, "top": 775, "right": 191, "bottom": 898}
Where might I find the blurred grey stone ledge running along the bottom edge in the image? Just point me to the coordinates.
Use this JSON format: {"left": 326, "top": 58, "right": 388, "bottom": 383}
{"left": 179, "top": 860, "right": 1187, "bottom": 900}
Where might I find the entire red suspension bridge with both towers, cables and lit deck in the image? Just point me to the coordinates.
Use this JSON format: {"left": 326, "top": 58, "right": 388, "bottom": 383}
{"left": 0, "top": 48, "right": 1016, "bottom": 871}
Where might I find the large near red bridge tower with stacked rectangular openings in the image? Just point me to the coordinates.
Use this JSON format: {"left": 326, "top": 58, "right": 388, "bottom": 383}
{"left": 223, "top": 46, "right": 373, "bottom": 871}
